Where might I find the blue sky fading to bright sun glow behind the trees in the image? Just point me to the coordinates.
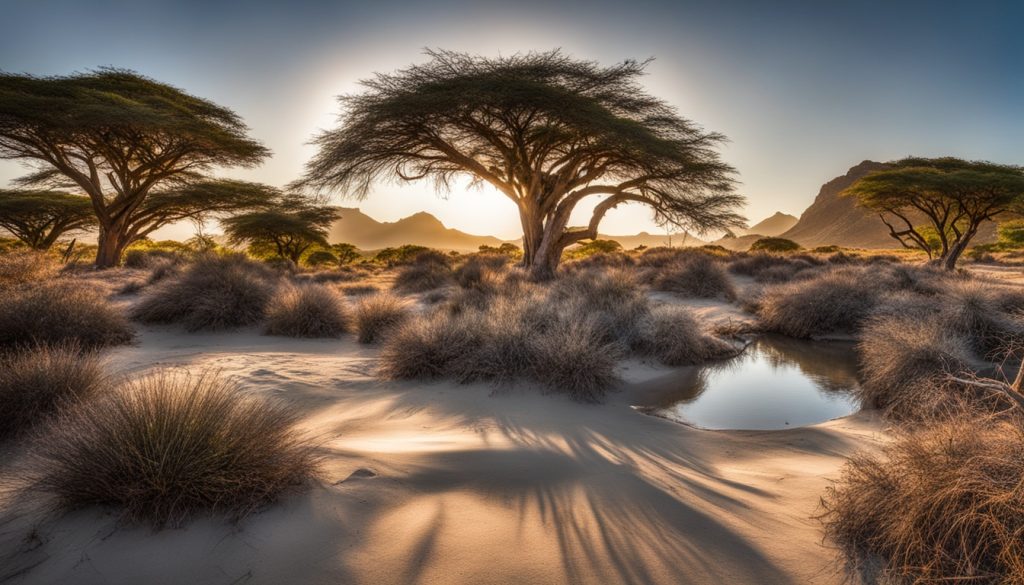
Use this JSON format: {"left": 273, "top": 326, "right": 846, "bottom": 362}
{"left": 0, "top": 0, "right": 1024, "bottom": 238}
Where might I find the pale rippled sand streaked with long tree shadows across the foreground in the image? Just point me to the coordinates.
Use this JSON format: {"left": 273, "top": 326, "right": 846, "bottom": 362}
{"left": 0, "top": 288, "right": 886, "bottom": 585}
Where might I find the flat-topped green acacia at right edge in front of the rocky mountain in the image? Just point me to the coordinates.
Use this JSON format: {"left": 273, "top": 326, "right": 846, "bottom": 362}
{"left": 845, "top": 157, "right": 1024, "bottom": 270}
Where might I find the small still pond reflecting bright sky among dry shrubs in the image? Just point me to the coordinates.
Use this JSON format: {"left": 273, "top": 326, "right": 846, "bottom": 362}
{"left": 640, "top": 336, "right": 859, "bottom": 430}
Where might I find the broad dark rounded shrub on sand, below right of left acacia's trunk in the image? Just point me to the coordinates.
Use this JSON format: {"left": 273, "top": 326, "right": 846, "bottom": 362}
{"left": 132, "top": 254, "right": 280, "bottom": 331}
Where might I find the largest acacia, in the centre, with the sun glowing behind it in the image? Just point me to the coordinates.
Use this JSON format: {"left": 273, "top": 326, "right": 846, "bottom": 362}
{"left": 299, "top": 50, "right": 742, "bottom": 278}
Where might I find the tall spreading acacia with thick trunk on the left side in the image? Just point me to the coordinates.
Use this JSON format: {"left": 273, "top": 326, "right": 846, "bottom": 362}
{"left": 0, "top": 69, "right": 269, "bottom": 267}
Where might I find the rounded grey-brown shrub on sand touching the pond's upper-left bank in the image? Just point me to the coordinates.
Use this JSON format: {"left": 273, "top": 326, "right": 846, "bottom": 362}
{"left": 637, "top": 305, "right": 735, "bottom": 366}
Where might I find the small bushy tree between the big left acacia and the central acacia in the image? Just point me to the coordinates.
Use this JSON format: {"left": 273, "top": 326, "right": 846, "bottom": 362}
{"left": 220, "top": 195, "right": 341, "bottom": 264}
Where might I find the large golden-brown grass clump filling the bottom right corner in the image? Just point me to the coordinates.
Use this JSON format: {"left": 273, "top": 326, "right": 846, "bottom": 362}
{"left": 821, "top": 417, "right": 1024, "bottom": 584}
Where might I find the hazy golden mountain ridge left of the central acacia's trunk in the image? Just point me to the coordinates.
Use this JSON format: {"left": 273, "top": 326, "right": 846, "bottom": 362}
{"left": 328, "top": 208, "right": 502, "bottom": 252}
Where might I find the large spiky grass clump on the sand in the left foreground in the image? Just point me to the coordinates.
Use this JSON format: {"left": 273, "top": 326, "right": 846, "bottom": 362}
{"left": 30, "top": 373, "right": 316, "bottom": 527}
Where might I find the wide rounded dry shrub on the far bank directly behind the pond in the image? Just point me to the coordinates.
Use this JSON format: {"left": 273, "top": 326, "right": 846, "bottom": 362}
{"left": 758, "top": 269, "right": 885, "bottom": 338}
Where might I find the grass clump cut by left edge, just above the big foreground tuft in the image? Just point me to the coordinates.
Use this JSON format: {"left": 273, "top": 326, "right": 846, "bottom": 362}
{"left": 0, "top": 344, "right": 108, "bottom": 440}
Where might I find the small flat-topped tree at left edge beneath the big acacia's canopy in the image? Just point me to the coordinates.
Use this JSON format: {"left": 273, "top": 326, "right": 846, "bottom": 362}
{"left": 0, "top": 190, "right": 96, "bottom": 250}
